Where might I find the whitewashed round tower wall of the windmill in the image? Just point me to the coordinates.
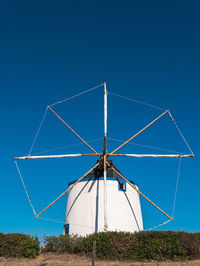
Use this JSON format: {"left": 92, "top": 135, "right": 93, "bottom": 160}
{"left": 65, "top": 179, "right": 143, "bottom": 236}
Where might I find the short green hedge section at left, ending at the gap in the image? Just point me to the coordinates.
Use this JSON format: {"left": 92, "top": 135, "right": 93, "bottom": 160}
{"left": 0, "top": 233, "right": 40, "bottom": 258}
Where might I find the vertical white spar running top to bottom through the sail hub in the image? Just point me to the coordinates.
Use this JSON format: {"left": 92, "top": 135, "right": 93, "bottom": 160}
{"left": 103, "top": 82, "right": 108, "bottom": 231}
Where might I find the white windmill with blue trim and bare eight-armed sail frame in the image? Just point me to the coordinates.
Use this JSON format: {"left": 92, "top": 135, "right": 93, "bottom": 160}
{"left": 14, "top": 82, "right": 194, "bottom": 235}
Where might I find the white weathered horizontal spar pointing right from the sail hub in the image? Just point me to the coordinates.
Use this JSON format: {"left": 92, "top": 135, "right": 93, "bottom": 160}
{"left": 107, "top": 153, "right": 194, "bottom": 158}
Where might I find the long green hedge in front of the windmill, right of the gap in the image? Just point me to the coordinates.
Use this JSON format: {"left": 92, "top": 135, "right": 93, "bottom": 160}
{"left": 43, "top": 231, "right": 200, "bottom": 261}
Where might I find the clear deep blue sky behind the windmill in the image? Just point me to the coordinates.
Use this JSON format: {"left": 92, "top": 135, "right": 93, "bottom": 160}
{"left": 0, "top": 0, "right": 200, "bottom": 236}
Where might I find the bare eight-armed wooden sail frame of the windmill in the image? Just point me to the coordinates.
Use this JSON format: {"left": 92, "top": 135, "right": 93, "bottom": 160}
{"left": 14, "top": 82, "right": 194, "bottom": 231}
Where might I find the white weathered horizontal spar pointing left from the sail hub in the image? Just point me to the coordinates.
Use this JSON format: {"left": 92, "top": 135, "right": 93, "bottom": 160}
{"left": 14, "top": 153, "right": 100, "bottom": 160}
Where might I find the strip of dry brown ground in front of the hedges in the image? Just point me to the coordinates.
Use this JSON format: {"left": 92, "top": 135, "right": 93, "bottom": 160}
{"left": 0, "top": 254, "right": 200, "bottom": 266}
